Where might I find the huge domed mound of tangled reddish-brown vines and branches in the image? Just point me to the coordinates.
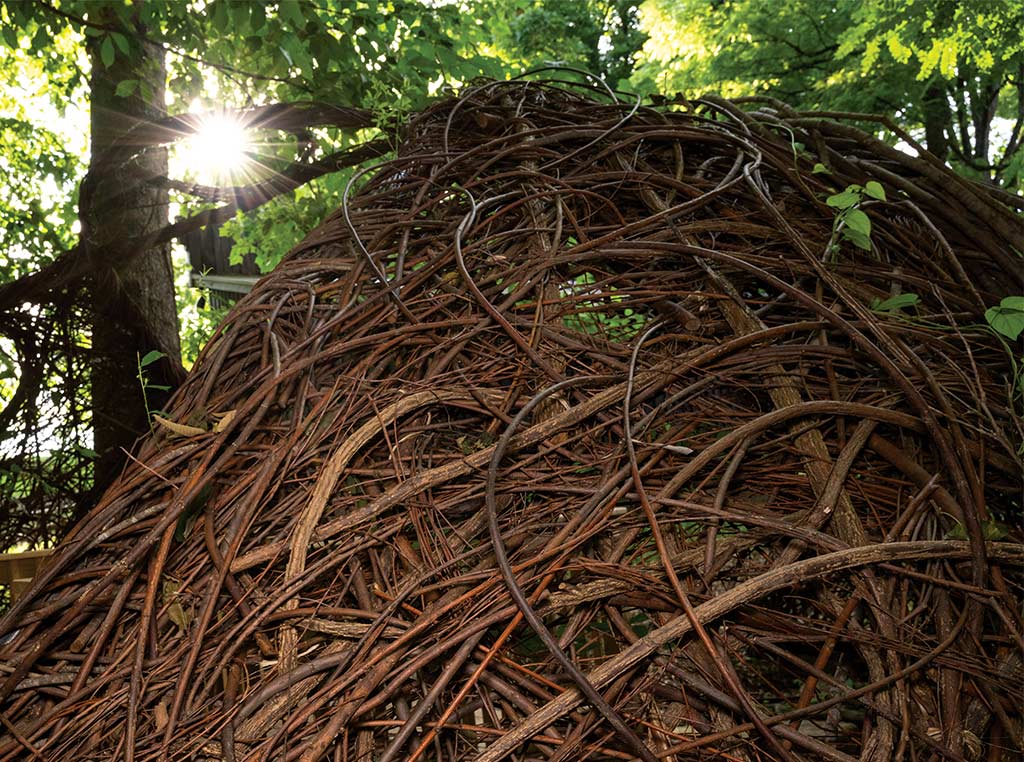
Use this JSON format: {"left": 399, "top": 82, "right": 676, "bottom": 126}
{"left": 0, "top": 82, "right": 1024, "bottom": 762}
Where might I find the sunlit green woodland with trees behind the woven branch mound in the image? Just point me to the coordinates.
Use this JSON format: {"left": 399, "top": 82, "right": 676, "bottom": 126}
{"left": 0, "top": 0, "right": 1024, "bottom": 551}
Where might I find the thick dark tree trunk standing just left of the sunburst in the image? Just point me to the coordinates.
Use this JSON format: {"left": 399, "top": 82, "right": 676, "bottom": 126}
{"left": 80, "top": 13, "right": 183, "bottom": 496}
